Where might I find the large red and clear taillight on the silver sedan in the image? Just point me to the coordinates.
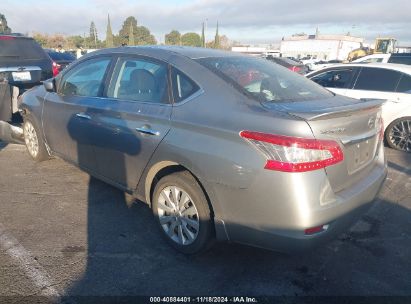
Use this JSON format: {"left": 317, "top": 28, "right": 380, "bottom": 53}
{"left": 240, "top": 131, "right": 344, "bottom": 172}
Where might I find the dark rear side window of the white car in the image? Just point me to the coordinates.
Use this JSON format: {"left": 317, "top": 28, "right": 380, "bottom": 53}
{"left": 354, "top": 68, "right": 401, "bottom": 92}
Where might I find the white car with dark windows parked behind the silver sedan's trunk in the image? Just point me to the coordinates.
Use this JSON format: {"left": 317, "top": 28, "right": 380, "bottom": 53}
{"left": 307, "top": 63, "right": 411, "bottom": 152}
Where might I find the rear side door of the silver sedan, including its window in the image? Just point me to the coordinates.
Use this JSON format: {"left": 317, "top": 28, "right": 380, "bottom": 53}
{"left": 88, "top": 55, "right": 172, "bottom": 189}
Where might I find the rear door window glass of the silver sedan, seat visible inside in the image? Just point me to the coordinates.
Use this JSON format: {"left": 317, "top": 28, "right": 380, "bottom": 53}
{"left": 107, "top": 58, "right": 169, "bottom": 103}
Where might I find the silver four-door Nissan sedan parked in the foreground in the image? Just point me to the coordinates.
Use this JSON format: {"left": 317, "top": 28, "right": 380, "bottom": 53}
{"left": 20, "top": 46, "right": 387, "bottom": 254}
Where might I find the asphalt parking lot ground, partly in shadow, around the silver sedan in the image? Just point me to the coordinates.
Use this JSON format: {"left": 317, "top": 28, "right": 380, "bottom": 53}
{"left": 0, "top": 143, "right": 411, "bottom": 301}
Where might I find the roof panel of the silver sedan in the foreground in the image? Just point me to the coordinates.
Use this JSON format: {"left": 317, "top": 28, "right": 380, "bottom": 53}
{"left": 85, "top": 45, "right": 246, "bottom": 59}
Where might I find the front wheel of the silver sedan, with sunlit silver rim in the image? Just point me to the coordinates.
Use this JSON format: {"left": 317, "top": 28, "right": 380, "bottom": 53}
{"left": 23, "top": 117, "right": 49, "bottom": 162}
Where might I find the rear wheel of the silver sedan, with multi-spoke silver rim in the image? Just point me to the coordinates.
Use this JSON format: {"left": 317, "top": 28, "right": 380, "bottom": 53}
{"left": 152, "top": 171, "right": 214, "bottom": 254}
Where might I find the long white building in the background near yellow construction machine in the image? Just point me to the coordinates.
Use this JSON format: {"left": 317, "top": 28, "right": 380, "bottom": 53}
{"left": 280, "top": 30, "right": 364, "bottom": 60}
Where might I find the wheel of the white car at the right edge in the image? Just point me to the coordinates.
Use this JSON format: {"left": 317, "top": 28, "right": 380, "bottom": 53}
{"left": 385, "top": 117, "right": 411, "bottom": 152}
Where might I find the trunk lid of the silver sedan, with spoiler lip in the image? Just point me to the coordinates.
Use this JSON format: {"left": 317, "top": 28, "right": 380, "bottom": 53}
{"left": 264, "top": 96, "right": 384, "bottom": 192}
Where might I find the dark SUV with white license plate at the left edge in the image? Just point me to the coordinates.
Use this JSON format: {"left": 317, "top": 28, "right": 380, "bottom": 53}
{"left": 0, "top": 34, "right": 53, "bottom": 122}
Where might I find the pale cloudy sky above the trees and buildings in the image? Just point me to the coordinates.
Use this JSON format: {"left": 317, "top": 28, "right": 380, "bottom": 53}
{"left": 0, "top": 0, "right": 411, "bottom": 45}
